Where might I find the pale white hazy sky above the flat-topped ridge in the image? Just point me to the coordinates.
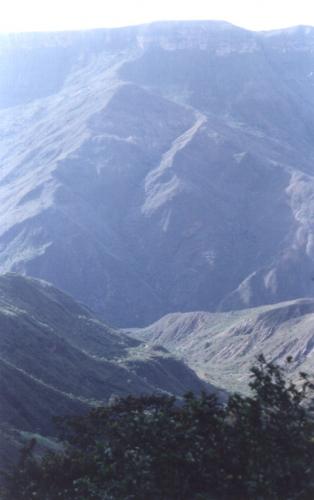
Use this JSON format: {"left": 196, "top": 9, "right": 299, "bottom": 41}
{"left": 0, "top": 0, "right": 314, "bottom": 31}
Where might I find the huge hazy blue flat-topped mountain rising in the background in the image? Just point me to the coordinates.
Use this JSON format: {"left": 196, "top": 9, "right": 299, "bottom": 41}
{"left": 0, "top": 22, "right": 314, "bottom": 327}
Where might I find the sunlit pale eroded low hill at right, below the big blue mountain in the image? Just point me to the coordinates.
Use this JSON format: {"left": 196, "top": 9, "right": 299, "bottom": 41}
{"left": 131, "top": 299, "right": 314, "bottom": 392}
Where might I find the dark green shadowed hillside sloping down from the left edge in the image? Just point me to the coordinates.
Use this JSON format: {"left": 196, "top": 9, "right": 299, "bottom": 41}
{"left": 0, "top": 274, "right": 214, "bottom": 467}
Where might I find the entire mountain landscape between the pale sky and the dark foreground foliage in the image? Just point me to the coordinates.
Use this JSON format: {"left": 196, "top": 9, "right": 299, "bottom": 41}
{"left": 0, "top": 21, "right": 314, "bottom": 467}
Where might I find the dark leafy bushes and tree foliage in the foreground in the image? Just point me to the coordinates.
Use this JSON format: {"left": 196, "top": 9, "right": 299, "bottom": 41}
{"left": 5, "top": 356, "right": 314, "bottom": 500}
